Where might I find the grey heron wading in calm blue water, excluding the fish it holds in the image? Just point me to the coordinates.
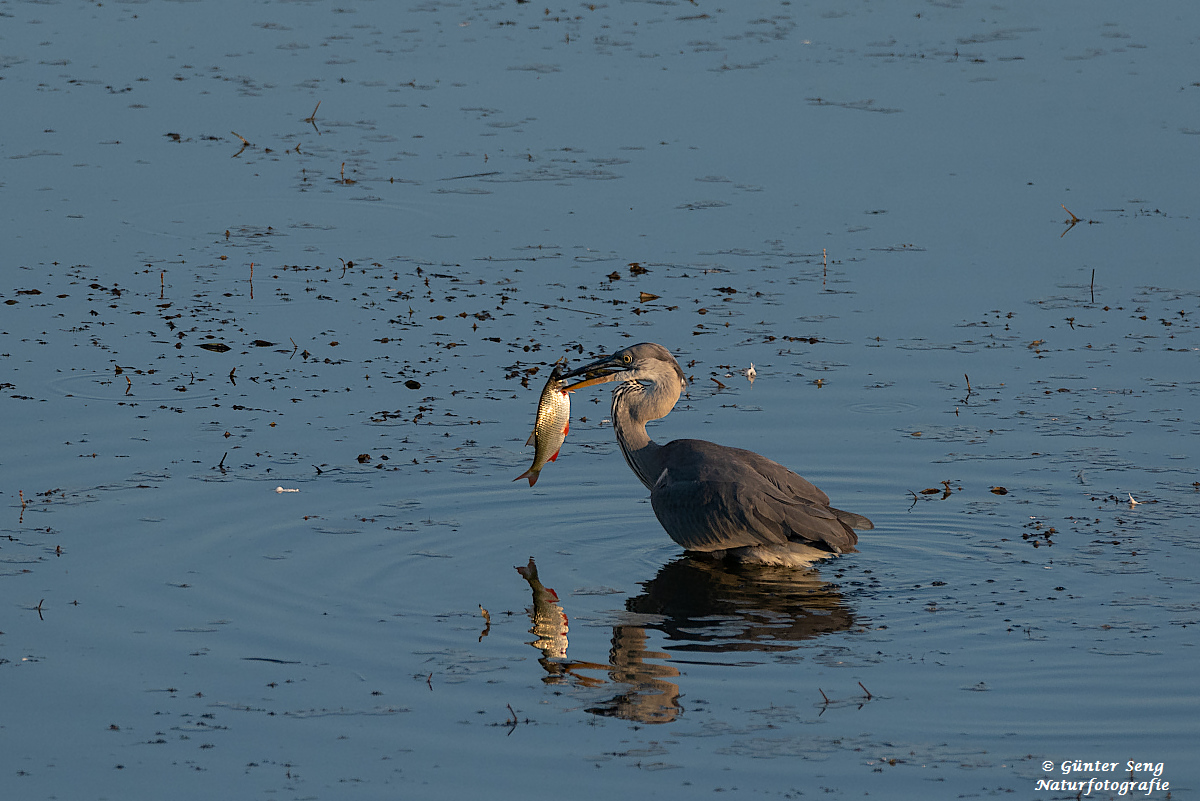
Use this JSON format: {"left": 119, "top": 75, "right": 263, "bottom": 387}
{"left": 563, "top": 342, "right": 875, "bottom": 565}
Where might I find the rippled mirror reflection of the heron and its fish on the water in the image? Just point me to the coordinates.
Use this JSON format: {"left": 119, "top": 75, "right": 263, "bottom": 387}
{"left": 517, "top": 556, "right": 854, "bottom": 723}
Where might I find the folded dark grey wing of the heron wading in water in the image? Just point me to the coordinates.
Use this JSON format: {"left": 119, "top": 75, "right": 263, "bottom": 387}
{"left": 650, "top": 440, "right": 869, "bottom": 553}
